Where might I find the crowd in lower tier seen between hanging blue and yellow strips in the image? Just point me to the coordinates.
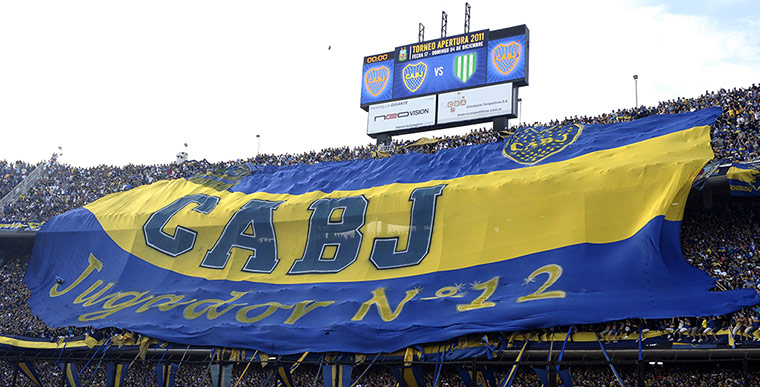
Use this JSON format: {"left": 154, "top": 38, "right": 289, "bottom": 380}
{"left": 0, "top": 361, "right": 760, "bottom": 387}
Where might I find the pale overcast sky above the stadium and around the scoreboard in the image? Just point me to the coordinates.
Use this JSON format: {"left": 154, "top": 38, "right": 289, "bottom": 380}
{"left": 0, "top": 0, "right": 760, "bottom": 166}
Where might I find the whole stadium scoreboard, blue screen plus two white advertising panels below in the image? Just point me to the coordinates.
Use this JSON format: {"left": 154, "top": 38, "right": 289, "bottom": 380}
{"left": 360, "top": 25, "right": 529, "bottom": 137}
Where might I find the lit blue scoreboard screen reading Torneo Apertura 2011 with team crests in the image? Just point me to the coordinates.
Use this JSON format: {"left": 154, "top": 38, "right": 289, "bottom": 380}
{"left": 361, "top": 25, "right": 528, "bottom": 110}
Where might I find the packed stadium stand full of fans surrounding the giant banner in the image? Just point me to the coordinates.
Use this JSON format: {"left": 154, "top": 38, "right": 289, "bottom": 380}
{"left": 0, "top": 85, "right": 760, "bottom": 387}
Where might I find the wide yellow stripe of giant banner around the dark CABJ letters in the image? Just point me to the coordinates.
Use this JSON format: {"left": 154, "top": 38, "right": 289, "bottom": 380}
{"left": 89, "top": 126, "right": 713, "bottom": 284}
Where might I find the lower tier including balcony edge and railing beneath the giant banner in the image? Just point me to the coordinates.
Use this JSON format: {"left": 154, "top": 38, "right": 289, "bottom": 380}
{"left": 0, "top": 329, "right": 760, "bottom": 387}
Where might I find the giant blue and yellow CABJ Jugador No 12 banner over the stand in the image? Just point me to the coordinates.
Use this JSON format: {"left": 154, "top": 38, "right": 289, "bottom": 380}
{"left": 26, "top": 108, "right": 760, "bottom": 354}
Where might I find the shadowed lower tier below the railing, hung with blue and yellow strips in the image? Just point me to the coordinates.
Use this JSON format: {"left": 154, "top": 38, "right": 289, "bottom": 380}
{"left": 0, "top": 350, "right": 760, "bottom": 387}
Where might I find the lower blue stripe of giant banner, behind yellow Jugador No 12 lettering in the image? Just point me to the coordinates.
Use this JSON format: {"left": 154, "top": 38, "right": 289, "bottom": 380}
{"left": 23, "top": 210, "right": 757, "bottom": 354}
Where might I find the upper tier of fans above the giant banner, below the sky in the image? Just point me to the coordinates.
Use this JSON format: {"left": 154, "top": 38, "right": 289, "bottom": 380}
{"left": 0, "top": 84, "right": 760, "bottom": 222}
